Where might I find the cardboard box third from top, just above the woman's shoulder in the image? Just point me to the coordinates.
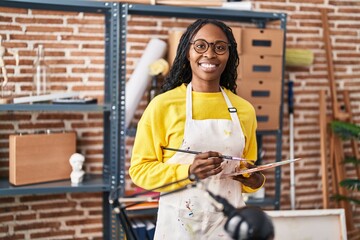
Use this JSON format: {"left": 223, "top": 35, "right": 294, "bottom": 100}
{"left": 236, "top": 79, "right": 281, "bottom": 104}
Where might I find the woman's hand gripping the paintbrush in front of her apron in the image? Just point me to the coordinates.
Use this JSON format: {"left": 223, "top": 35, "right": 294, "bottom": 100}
{"left": 189, "top": 152, "right": 223, "bottom": 179}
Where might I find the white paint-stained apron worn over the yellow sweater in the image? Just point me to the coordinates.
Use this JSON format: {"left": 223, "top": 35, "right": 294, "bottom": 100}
{"left": 155, "top": 83, "right": 245, "bottom": 240}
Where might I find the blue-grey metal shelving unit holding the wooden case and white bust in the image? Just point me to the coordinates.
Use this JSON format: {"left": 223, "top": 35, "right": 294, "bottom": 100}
{"left": 0, "top": 0, "right": 125, "bottom": 239}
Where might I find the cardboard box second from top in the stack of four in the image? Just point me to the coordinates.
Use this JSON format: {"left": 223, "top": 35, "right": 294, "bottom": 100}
{"left": 238, "top": 54, "right": 283, "bottom": 79}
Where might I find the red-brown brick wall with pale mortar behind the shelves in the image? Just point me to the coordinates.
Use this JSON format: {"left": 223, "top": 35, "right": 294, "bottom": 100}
{"left": 0, "top": 0, "right": 360, "bottom": 239}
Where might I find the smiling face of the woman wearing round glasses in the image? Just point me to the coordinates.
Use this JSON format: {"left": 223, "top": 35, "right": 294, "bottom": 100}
{"left": 188, "top": 24, "right": 229, "bottom": 91}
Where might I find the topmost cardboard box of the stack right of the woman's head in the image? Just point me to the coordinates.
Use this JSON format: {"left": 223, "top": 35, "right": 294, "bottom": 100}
{"left": 241, "top": 28, "right": 284, "bottom": 56}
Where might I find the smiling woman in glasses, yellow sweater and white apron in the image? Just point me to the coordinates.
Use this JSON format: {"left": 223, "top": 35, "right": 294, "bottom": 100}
{"left": 129, "top": 19, "right": 265, "bottom": 239}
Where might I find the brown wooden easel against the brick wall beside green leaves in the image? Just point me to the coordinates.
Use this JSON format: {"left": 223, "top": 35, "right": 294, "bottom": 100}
{"left": 319, "top": 9, "right": 360, "bottom": 230}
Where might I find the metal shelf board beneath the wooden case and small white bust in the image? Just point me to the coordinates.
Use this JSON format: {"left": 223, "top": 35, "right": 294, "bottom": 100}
{"left": 0, "top": 175, "right": 110, "bottom": 196}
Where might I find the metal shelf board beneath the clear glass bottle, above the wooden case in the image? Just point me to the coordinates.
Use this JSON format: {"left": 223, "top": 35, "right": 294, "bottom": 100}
{"left": 0, "top": 103, "right": 111, "bottom": 112}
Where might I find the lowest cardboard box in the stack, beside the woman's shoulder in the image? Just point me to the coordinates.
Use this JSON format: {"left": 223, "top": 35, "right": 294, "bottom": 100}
{"left": 253, "top": 104, "right": 281, "bottom": 130}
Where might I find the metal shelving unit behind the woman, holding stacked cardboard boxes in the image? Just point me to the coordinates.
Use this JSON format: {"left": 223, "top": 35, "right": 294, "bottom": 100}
{"left": 124, "top": 4, "right": 286, "bottom": 210}
